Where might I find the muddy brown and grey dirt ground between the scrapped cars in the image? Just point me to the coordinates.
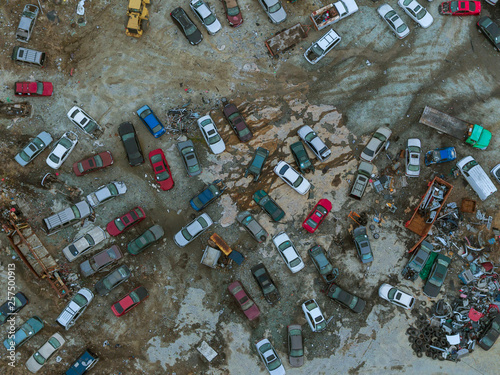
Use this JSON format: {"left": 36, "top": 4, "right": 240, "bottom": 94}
{"left": 0, "top": 0, "right": 500, "bottom": 374}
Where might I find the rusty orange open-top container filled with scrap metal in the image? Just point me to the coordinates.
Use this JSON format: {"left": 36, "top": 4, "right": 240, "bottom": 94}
{"left": 405, "top": 177, "right": 453, "bottom": 253}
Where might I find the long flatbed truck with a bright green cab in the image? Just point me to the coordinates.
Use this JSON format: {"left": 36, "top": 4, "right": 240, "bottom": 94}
{"left": 419, "top": 106, "right": 491, "bottom": 150}
